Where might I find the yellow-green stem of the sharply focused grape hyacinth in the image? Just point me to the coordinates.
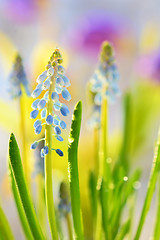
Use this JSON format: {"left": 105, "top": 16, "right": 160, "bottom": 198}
{"left": 45, "top": 66, "right": 58, "bottom": 240}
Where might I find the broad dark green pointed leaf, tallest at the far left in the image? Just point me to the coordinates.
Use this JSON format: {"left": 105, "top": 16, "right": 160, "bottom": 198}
{"left": 9, "top": 133, "right": 44, "bottom": 240}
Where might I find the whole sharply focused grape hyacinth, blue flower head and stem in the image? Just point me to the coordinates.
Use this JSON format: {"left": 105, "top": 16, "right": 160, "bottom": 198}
{"left": 30, "top": 48, "right": 71, "bottom": 240}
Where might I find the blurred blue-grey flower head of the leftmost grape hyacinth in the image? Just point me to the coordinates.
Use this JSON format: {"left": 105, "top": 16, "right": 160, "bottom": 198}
{"left": 8, "top": 55, "right": 30, "bottom": 98}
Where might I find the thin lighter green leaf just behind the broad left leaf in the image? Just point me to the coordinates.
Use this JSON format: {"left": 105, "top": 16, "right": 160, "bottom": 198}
{"left": 8, "top": 164, "right": 33, "bottom": 240}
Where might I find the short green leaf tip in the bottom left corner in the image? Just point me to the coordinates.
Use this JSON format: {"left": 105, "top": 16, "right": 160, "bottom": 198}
{"left": 0, "top": 203, "right": 14, "bottom": 240}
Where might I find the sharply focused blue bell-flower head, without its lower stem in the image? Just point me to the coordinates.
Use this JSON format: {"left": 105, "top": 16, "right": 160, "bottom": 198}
{"left": 30, "top": 48, "right": 71, "bottom": 158}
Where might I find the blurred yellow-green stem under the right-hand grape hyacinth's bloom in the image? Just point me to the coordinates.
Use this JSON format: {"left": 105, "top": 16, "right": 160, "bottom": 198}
{"left": 96, "top": 97, "right": 111, "bottom": 240}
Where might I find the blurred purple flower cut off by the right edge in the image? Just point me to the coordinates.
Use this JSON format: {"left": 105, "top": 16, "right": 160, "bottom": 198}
{"left": 136, "top": 49, "right": 160, "bottom": 82}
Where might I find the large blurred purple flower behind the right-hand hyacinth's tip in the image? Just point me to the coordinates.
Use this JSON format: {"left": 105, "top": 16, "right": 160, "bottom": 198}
{"left": 67, "top": 11, "right": 127, "bottom": 55}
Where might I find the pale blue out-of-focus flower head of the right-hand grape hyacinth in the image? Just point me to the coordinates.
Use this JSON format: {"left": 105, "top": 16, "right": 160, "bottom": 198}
{"left": 88, "top": 42, "right": 120, "bottom": 128}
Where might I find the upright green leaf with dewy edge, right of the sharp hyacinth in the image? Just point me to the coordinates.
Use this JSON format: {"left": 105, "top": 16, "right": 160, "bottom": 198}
{"left": 68, "top": 101, "right": 83, "bottom": 240}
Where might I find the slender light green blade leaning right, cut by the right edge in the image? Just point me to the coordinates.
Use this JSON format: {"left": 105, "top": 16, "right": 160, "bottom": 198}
{"left": 134, "top": 130, "right": 160, "bottom": 240}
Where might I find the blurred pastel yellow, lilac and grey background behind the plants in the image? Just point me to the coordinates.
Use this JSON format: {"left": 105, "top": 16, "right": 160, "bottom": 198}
{"left": 0, "top": 0, "right": 160, "bottom": 240}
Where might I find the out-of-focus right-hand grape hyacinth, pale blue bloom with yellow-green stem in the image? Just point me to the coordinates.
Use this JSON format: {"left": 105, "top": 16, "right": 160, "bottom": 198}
{"left": 88, "top": 42, "right": 120, "bottom": 239}
